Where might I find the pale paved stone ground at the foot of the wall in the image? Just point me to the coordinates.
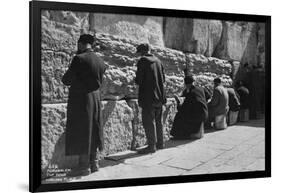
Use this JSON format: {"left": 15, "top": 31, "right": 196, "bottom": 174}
{"left": 43, "top": 119, "right": 265, "bottom": 182}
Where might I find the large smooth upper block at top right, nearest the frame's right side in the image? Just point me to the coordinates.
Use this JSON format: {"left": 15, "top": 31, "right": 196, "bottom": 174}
{"left": 213, "top": 21, "right": 257, "bottom": 64}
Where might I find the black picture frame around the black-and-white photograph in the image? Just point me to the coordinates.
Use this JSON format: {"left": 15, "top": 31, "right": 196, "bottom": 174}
{"left": 29, "top": 1, "right": 271, "bottom": 192}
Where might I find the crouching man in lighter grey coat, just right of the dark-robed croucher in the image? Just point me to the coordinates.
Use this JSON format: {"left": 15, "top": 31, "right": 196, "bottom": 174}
{"left": 208, "top": 78, "right": 229, "bottom": 129}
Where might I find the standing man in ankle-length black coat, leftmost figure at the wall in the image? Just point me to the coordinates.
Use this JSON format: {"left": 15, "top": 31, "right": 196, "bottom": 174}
{"left": 62, "top": 34, "right": 106, "bottom": 175}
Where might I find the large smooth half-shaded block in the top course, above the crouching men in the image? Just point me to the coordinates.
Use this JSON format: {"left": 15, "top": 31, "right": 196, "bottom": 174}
{"left": 164, "top": 17, "right": 222, "bottom": 56}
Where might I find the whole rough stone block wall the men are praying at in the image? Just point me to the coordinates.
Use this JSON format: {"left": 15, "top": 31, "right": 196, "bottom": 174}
{"left": 41, "top": 11, "right": 264, "bottom": 177}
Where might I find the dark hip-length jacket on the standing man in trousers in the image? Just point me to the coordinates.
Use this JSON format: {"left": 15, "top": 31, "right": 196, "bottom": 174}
{"left": 135, "top": 54, "right": 166, "bottom": 108}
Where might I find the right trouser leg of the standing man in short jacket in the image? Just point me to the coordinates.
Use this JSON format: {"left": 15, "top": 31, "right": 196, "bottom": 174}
{"left": 155, "top": 106, "right": 164, "bottom": 149}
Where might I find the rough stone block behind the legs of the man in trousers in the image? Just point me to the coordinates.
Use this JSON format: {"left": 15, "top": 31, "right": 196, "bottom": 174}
{"left": 128, "top": 98, "right": 177, "bottom": 149}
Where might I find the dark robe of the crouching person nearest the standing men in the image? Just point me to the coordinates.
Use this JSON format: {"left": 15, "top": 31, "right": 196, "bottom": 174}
{"left": 168, "top": 86, "right": 208, "bottom": 139}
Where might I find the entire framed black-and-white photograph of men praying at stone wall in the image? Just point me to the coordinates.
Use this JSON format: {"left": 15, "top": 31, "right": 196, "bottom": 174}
{"left": 29, "top": 1, "right": 271, "bottom": 192}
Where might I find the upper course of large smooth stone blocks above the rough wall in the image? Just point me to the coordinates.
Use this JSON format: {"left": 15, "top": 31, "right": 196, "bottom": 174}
{"left": 42, "top": 11, "right": 265, "bottom": 65}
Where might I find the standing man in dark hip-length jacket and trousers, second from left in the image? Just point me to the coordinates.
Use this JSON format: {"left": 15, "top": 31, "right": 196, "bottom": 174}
{"left": 135, "top": 44, "right": 166, "bottom": 154}
